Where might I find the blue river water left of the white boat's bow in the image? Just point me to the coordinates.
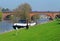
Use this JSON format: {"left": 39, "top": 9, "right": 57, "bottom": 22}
{"left": 0, "top": 21, "right": 13, "bottom": 33}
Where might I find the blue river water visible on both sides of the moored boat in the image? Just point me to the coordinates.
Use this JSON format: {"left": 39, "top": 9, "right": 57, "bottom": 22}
{"left": 0, "top": 18, "right": 49, "bottom": 33}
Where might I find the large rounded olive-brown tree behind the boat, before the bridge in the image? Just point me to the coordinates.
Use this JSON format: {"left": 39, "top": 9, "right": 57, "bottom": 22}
{"left": 14, "top": 3, "right": 32, "bottom": 22}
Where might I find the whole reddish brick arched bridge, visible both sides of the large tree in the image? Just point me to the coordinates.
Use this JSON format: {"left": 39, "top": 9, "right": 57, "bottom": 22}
{"left": 2, "top": 11, "right": 60, "bottom": 20}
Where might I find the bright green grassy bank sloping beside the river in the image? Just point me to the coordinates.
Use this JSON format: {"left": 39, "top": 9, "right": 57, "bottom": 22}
{"left": 0, "top": 21, "right": 60, "bottom": 41}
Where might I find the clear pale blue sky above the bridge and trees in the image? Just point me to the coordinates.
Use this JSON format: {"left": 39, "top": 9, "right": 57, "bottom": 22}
{"left": 0, "top": 0, "right": 60, "bottom": 11}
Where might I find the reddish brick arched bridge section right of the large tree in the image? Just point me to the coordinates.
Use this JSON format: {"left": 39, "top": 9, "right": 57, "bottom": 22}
{"left": 30, "top": 11, "right": 60, "bottom": 19}
